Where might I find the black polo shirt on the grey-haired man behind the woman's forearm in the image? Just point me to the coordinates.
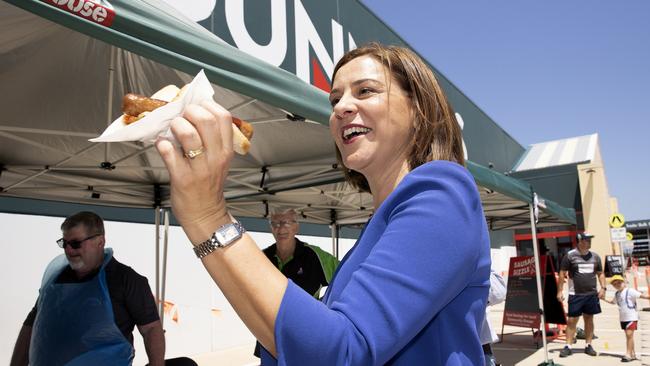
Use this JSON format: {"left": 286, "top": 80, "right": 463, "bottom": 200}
{"left": 264, "top": 238, "right": 328, "bottom": 296}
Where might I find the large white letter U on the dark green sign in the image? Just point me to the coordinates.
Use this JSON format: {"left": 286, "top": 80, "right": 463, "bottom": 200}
{"left": 224, "top": 0, "right": 286, "bottom": 67}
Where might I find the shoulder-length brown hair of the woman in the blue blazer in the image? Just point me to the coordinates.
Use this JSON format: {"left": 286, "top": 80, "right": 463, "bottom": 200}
{"left": 332, "top": 43, "right": 465, "bottom": 192}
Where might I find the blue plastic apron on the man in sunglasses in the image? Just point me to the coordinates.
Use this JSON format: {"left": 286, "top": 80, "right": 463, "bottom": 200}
{"left": 29, "top": 248, "right": 134, "bottom": 366}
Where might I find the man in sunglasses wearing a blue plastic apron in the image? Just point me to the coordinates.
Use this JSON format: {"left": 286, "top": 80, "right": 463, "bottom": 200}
{"left": 11, "top": 212, "right": 165, "bottom": 366}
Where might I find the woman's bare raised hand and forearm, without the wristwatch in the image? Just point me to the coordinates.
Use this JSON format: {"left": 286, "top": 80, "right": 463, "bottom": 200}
{"left": 156, "top": 101, "right": 288, "bottom": 355}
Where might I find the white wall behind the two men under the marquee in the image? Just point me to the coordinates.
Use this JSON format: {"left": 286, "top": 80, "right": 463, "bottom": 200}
{"left": 0, "top": 213, "right": 353, "bottom": 366}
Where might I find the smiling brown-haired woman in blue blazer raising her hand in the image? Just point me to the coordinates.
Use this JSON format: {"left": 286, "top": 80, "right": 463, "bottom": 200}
{"left": 157, "top": 44, "right": 490, "bottom": 366}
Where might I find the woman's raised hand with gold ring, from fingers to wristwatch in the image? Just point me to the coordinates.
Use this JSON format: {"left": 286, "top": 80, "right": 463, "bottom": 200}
{"left": 156, "top": 101, "right": 233, "bottom": 244}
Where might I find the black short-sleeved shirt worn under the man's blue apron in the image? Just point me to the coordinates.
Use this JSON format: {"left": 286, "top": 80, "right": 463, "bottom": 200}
{"left": 23, "top": 258, "right": 159, "bottom": 344}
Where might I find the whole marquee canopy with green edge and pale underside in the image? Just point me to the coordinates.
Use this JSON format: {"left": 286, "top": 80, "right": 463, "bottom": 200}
{"left": 0, "top": 0, "right": 575, "bottom": 234}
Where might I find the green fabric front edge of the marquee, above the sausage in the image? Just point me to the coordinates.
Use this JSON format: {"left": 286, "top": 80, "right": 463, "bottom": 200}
{"left": 5, "top": 0, "right": 331, "bottom": 123}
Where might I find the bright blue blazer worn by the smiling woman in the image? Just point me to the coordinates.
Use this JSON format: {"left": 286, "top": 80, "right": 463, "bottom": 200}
{"left": 262, "top": 161, "right": 490, "bottom": 366}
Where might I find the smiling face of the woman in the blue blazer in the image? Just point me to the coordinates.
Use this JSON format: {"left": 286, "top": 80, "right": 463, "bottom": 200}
{"left": 330, "top": 56, "right": 413, "bottom": 178}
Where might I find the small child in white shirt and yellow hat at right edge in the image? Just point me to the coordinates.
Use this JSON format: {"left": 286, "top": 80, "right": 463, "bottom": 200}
{"left": 605, "top": 275, "right": 650, "bottom": 362}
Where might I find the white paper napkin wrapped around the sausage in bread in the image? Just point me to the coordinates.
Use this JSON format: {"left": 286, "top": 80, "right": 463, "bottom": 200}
{"left": 88, "top": 70, "right": 214, "bottom": 143}
